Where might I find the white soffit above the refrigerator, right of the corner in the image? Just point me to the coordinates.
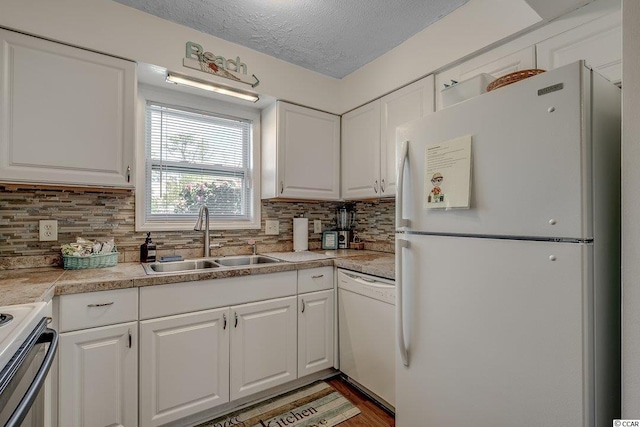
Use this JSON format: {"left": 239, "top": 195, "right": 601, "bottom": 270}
{"left": 341, "top": 0, "right": 621, "bottom": 112}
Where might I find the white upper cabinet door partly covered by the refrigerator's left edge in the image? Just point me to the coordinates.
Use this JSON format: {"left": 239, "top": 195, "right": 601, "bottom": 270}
{"left": 380, "top": 75, "right": 434, "bottom": 197}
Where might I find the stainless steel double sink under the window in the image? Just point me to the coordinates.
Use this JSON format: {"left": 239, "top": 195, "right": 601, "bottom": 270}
{"left": 143, "top": 255, "right": 281, "bottom": 274}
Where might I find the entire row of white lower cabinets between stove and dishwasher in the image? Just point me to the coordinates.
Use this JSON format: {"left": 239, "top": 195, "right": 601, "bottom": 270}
{"left": 58, "top": 267, "right": 335, "bottom": 427}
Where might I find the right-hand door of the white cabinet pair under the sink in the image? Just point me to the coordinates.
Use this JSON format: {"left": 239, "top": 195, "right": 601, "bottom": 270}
{"left": 230, "top": 296, "right": 297, "bottom": 400}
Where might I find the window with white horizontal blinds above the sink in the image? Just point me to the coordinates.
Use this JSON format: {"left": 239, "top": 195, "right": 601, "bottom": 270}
{"left": 146, "top": 101, "right": 252, "bottom": 221}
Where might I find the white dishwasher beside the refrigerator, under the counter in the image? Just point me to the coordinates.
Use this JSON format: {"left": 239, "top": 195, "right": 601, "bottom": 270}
{"left": 338, "top": 269, "right": 396, "bottom": 408}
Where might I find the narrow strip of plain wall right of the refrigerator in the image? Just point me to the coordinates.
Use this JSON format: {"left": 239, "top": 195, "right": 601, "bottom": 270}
{"left": 622, "top": 0, "right": 640, "bottom": 419}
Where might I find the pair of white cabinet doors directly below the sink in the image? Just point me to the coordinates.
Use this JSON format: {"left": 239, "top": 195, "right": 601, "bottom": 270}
{"left": 140, "top": 296, "right": 297, "bottom": 427}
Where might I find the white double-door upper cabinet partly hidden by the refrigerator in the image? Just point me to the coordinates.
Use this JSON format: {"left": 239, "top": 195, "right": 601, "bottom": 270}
{"left": 341, "top": 75, "right": 433, "bottom": 200}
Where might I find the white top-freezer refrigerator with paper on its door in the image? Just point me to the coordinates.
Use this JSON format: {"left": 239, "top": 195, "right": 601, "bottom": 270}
{"left": 396, "top": 61, "right": 620, "bottom": 427}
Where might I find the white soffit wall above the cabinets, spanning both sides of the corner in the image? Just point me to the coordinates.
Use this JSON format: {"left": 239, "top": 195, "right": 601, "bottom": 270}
{"left": 0, "top": 0, "right": 540, "bottom": 114}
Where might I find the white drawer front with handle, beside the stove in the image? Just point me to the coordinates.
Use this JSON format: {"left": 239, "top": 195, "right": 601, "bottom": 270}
{"left": 59, "top": 288, "right": 138, "bottom": 332}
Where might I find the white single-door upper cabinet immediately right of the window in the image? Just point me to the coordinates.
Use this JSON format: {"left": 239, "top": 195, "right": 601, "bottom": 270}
{"left": 262, "top": 101, "right": 340, "bottom": 200}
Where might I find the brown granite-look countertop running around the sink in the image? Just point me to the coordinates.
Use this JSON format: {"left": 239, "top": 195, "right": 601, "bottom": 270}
{"left": 0, "top": 250, "right": 395, "bottom": 307}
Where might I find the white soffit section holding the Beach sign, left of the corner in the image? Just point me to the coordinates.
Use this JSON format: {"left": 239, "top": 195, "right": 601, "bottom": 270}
{"left": 0, "top": 0, "right": 341, "bottom": 112}
